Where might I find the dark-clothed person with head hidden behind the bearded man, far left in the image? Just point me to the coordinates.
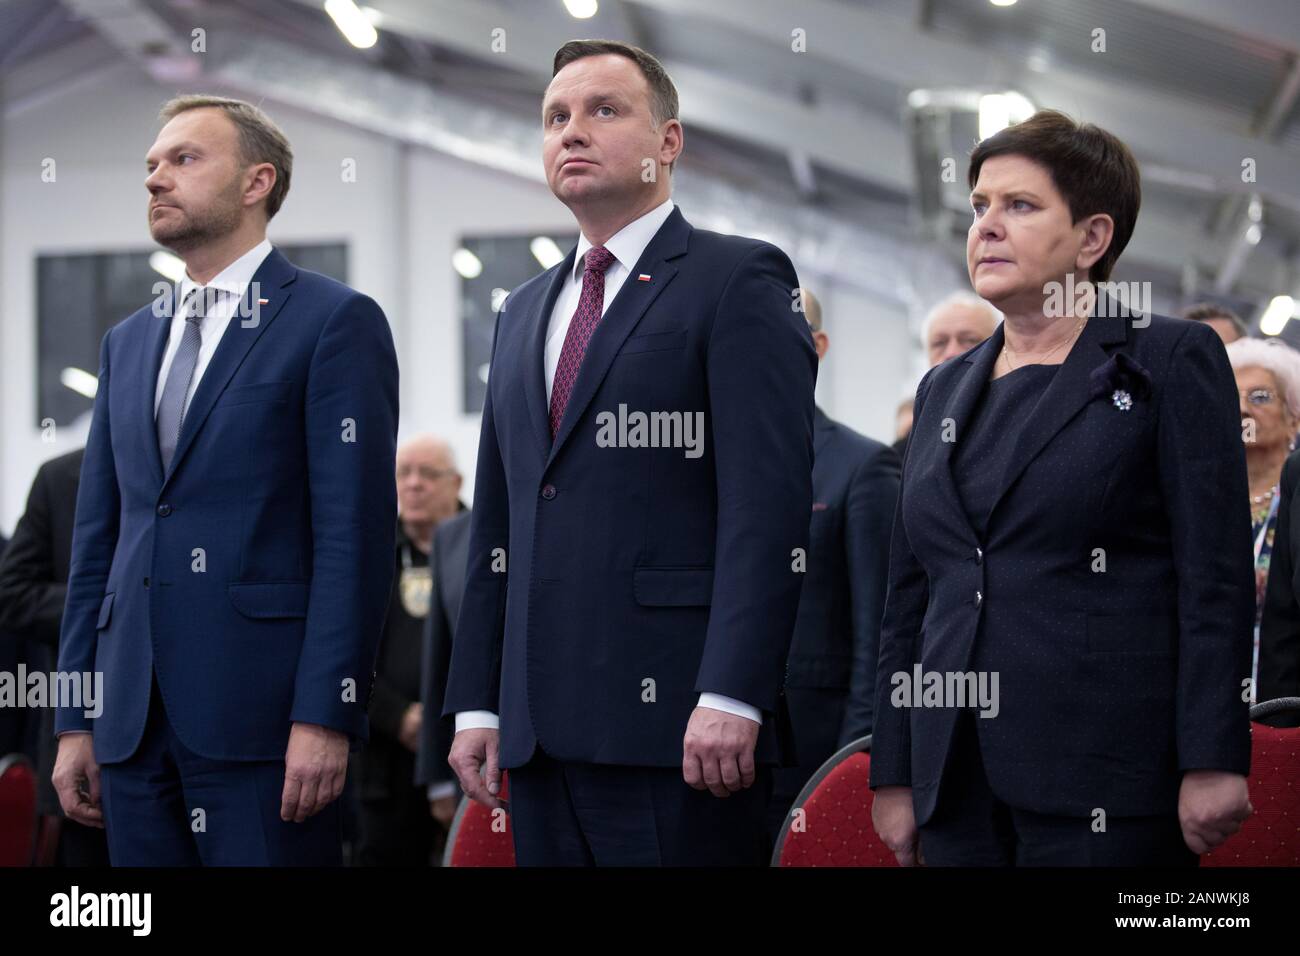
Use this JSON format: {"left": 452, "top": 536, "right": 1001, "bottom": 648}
{"left": 0, "top": 449, "right": 108, "bottom": 866}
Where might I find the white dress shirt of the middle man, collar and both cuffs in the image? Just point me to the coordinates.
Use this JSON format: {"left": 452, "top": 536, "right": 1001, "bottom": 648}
{"left": 456, "top": 199, "right": 763, "bottom": 734}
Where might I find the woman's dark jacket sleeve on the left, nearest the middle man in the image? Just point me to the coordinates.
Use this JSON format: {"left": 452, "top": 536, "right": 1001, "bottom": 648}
{"left": 871, "top": 369, "right": 935, "bottom": 790}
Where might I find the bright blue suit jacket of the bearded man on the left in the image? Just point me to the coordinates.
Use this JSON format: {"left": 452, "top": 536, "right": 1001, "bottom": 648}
{"left": 56, "top": 250, "right": 398, "bottom": 763}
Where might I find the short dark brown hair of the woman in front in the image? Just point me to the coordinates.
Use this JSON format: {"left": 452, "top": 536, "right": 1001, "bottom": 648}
{"left": 966, "top": 109, "right": 1141, "bottom": 282}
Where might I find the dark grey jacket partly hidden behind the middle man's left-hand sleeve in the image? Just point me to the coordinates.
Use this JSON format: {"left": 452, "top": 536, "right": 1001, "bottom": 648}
{"left": 415, "top": 510, "right": 472, "bottom": 786}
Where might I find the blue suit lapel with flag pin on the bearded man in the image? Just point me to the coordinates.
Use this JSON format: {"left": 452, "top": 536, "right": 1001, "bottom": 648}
{"left": 155, "top": 248, "right": 298, "bottom": 477}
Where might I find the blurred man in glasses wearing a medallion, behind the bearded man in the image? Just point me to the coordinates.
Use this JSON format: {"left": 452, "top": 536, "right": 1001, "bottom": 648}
{"left": 355, "top": 434, "right": 464, "bottom": 866}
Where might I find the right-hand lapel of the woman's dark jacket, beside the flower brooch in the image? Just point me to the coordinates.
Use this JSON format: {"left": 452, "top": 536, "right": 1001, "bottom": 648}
{"left": 989, "top": 313, "right": 1128, "bottom": 515}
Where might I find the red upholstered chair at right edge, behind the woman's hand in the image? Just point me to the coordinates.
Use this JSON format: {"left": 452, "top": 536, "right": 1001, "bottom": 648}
{"left": 1201, "top": 697, "right": 1300, "bottom": 866}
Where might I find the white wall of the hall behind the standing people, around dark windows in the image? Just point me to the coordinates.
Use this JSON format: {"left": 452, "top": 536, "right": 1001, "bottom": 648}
{"left": 0, "top": 62, "right": 915, "bottom": 533}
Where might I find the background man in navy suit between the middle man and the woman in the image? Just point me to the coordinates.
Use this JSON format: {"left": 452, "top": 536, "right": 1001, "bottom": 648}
{"left": 768, "top": 289, "right": 902, "bottom": 838}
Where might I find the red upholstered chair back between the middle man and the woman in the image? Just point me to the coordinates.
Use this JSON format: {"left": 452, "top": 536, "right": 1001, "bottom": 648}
{"left": 772, "top": 736, "right": 898, "bottom": 866}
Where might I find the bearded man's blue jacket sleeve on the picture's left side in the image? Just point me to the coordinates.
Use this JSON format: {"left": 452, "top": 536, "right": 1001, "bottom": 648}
{"left": 55, "top": 329, "right": 122, "bottom": 734}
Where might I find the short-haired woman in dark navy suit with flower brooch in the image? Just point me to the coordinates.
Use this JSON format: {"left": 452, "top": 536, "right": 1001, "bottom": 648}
{"left": 871, "top": 111, "right": 1255, "bottom": 865}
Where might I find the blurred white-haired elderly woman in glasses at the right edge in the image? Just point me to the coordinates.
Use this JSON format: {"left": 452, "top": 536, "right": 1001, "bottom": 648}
{"left": 1227, "top": 338, "right": 1300, "bottom": 700}
